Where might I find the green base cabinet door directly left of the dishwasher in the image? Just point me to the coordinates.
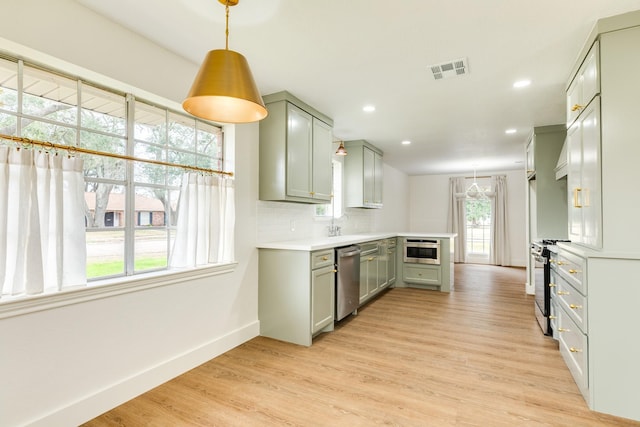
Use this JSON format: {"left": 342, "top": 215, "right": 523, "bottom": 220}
{"left": 311, "top": 266, "right": 335, "bottom": 334}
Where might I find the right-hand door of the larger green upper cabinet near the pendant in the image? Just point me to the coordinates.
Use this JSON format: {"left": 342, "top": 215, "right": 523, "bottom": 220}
{"left": 312, "top": 117, "right": 333, "bottom": 201}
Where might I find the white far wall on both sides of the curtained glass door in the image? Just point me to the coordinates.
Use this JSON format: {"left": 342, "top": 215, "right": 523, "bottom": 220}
{"left": 409, "top": 170, "right": 529, "bottom": 267}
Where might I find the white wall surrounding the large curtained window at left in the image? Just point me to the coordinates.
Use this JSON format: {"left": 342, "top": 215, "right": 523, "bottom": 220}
{"left": 0, "top": 0, "right": 259, "bottom": 426}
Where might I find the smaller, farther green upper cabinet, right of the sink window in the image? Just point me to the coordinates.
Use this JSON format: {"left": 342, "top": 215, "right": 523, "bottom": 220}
{"left": 344, "top": 140, "right": 383, "bottom": 208}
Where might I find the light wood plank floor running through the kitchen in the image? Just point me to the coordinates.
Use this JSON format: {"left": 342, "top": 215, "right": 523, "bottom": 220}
{"left": 86, "top": 265, "right": 640, "bottom": 426}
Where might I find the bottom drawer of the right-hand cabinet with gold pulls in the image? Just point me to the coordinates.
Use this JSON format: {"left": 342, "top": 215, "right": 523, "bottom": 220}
{"left": 557, "top": 309, "right": 589, "bottom": 401}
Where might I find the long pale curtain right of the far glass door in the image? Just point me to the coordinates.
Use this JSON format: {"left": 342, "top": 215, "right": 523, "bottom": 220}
{"left": 489, "top": 175, "right": 511, "bottom": 265}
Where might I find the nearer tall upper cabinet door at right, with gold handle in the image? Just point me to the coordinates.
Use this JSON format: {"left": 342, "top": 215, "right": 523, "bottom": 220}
{"left": 580, "top": 97, "right": 602, "bottom": 248}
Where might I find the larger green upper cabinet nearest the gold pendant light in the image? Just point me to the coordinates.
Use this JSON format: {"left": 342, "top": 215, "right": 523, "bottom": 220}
{"left": 260, "top": 92, "right": 333, "bottom": 203}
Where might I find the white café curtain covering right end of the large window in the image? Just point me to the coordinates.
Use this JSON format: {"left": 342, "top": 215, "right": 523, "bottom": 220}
{"left": 169, "top": 173, "right": 235, "bottom": 267}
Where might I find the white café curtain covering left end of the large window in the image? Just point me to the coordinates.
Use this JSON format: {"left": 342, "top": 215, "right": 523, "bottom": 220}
{"left": 0, "top": 147, "right": 86, "bottom": 295}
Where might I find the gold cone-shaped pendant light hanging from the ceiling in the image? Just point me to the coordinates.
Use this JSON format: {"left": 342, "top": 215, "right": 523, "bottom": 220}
{"left": 182, "top": 0, "right": 268, "bottom": 123}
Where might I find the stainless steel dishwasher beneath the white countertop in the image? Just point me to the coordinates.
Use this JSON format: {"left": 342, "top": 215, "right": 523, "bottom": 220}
{"left": 336, "top": 245, "right": 360, "bottom": 320}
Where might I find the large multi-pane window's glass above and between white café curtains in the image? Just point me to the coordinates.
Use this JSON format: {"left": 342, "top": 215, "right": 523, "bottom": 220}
{"left": 0, "top": 59, "right": 223, "bottom": 280}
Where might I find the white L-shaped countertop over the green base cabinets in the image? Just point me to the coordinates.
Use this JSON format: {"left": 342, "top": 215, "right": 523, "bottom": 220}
{"left": 256, "top": 232, "right": 457, "bottom": 251}
